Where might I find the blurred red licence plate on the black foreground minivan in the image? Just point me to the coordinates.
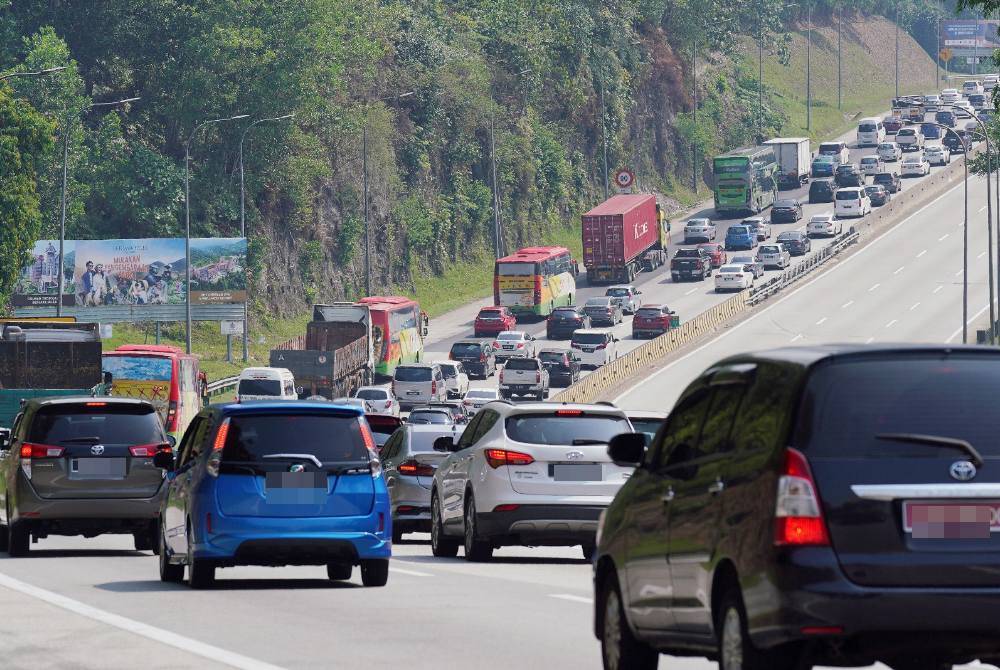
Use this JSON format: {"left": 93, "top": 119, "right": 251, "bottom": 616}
{"left": 903, "top": 501, "right": 1000, "bottom": 540}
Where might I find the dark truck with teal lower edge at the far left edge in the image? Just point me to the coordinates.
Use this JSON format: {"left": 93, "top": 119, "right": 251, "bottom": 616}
{"left": 0, "top": 319, "right": 105, "bottom": 428}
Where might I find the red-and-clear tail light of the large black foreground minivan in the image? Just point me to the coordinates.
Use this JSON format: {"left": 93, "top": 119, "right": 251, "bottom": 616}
{"left": 774, "top": 449, "right": 830, "bottom": 546}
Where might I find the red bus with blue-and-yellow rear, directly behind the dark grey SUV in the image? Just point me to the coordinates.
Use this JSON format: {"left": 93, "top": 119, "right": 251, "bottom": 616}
{"left": 103, "top": 344, "right": 201, "bottom": 442}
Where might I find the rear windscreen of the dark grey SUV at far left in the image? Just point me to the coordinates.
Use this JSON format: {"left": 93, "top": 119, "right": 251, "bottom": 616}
{"left": 28, "top": 403, "right": 167, "bottom": 444}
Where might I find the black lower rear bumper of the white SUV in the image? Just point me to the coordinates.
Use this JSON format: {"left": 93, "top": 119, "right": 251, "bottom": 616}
{"left": 476, "top": 505, "right": 604, "bottom": 546}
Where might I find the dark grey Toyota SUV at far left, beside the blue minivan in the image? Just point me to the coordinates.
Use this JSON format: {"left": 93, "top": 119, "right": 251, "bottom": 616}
{"left": 0, "top": 396, "right": 173, "bottom": 556}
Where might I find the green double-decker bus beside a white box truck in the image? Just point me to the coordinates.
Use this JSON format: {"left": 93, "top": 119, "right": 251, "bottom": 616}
{"left": 712, "top": 146, "right": 778, "bottom": 214}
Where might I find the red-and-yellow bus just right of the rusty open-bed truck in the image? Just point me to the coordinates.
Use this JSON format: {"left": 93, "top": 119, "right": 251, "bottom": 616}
{"left": 358, "top": 295, "right": 427, "bottom": 377}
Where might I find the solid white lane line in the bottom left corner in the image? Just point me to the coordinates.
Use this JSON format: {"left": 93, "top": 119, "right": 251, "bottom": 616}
{"left": 0, "top": 573, "right": 281, "bottom": 670}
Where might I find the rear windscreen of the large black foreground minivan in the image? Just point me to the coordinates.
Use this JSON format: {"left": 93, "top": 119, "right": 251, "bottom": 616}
{"left": 796, "top": 356, "right": 1000, "bottom": 459}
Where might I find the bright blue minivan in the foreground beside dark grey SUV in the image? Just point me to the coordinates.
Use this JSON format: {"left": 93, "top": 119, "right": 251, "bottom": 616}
{"left": 153, "top": 401, "right": 392, "bottom": 588}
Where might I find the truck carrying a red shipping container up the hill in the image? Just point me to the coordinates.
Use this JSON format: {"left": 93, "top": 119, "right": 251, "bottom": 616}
{"left": 583, "top": 193, "right": 669, "bottom": 284}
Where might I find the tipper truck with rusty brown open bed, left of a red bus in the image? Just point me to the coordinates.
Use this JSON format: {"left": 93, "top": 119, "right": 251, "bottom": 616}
{"left": 270, "top": 302, "right": 373, "bottom": 399}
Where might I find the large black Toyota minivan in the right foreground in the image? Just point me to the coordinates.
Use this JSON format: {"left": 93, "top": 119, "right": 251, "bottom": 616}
{"left": 594, "top": 345, "right": 1000, "bottom": 670}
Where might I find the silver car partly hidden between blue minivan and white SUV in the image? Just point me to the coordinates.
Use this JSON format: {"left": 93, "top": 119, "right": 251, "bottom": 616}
{"left": 381, "top": 424, "right": 463, "bottom": 542}
